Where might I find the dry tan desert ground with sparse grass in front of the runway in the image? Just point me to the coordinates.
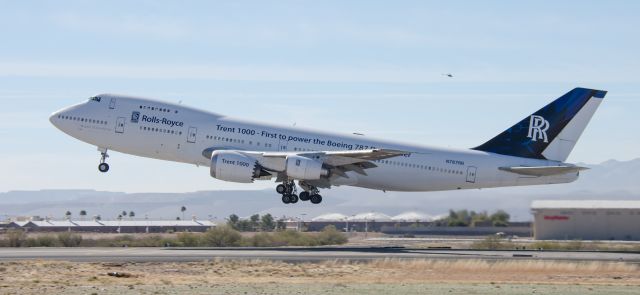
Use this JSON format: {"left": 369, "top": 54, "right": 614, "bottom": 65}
{"left": 0, "top": 259, "right": 640, "bottom": 294}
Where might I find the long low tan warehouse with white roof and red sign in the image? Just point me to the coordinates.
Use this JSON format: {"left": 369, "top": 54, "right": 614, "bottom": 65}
{"left": 531, "top": 200, "right": 640, "bottom": 240}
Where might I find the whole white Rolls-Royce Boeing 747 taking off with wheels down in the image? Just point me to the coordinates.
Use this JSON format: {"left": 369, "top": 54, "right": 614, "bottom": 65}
{"left": 50, "top": 88, "right": 606, "bottom": 204}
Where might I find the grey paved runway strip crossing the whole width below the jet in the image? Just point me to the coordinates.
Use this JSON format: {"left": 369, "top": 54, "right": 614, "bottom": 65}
{"left": 0, "top": 247, "right": 640, "bottom": 263}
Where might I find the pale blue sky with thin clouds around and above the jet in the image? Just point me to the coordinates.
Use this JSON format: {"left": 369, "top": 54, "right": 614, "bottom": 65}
{"left": 0, "top": 1, "right": 640, "bottom": 192}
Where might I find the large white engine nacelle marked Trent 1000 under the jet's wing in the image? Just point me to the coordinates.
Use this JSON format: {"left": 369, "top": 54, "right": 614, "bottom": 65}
{"left": 209, "top": 151, "right": 261, "bottom": 183}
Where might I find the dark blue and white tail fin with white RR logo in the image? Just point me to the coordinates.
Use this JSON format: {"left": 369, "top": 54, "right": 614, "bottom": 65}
{"left": 473, "top": 88, "right": 607, "bottom": 161}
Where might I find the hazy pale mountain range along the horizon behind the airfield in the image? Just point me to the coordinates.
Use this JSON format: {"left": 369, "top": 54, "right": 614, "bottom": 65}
{"left": 0, "top": 158, "right": 640, "bottom": 220}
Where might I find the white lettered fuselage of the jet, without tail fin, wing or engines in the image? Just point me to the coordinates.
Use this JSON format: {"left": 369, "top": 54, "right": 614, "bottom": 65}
{"left": 50, "top": 95, "right": 578, "bottom": 191}
